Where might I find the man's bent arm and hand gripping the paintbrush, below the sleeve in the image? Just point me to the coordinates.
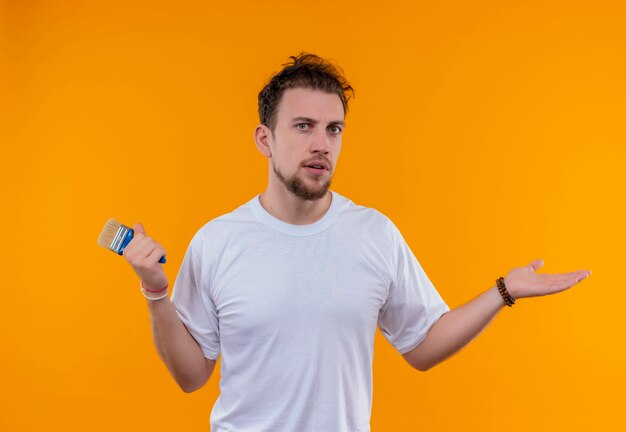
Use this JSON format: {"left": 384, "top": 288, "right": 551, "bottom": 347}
{"left": 124, "top": 224, "right": 215, "bottom": 392}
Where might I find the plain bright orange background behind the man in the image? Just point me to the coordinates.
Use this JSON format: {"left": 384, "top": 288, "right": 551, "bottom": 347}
{"left": 0, "top": 0, "right": 626, "bottom": 431}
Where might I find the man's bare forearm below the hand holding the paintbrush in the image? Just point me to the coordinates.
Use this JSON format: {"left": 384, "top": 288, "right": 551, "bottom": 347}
{"left": 148, "top": 298, "right": 215, "bottom": 392}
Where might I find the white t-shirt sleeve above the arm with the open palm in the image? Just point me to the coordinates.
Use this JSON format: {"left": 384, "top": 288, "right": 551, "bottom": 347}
{"left": 378, "top": 226, "right": 450, "bottom": 354}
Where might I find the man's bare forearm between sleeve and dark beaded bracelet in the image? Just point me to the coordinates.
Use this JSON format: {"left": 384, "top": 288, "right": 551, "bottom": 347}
{"left": 404, "top": 286, "right": 504, "bottom": 370}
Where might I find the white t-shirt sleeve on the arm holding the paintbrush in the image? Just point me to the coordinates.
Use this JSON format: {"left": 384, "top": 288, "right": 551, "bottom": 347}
{"left": 171, "top": 235, "right": 220, "bottom": 360}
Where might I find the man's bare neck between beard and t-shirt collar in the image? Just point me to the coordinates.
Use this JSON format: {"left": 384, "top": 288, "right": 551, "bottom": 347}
{"left": 260, "top": 187, "right": 332, "bottom": 225}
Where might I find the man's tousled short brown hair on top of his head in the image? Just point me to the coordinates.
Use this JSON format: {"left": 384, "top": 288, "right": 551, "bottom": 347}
{"left": 259, "top": 52, "right": 354, "bottom": 132}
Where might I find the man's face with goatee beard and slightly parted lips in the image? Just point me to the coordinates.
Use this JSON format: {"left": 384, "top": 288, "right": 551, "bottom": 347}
{"left": 260, "top": 88, "right": 344, "bottom": 200}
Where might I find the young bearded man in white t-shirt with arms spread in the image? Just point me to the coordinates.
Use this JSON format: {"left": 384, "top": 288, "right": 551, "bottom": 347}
{"left": 124, "top": 54, "right": 590, "bottom": 432}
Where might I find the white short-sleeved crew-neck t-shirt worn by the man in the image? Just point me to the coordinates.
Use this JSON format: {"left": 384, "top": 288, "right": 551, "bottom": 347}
{"left": 171, "top": 192, "right": 449, "bottom": 432}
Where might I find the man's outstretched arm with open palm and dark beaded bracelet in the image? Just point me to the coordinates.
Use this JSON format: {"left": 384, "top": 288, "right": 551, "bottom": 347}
{"left": 404, "top": 260, "right": 591, "bottom": 371}
